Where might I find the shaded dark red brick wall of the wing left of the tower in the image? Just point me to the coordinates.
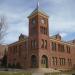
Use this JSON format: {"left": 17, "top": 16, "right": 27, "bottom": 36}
{"left": 8, "top": 41, "right": 27, "bottom": 68}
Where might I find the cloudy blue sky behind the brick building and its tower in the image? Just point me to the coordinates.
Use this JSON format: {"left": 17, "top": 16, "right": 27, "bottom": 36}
{"left": 0, "top": 0, "right": 75, "bottom": 44}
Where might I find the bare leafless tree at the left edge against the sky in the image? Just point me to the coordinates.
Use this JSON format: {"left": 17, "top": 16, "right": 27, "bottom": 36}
{"left": 0, "top": 16, "right": 7, "bottom": 44}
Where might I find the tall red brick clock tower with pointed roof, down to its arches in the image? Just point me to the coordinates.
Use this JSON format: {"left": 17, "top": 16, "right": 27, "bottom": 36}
{"left": 28, "top": 3, "right": 50, "bottom": 68}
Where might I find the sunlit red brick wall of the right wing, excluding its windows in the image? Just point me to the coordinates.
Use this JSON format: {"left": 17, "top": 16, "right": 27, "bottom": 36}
{"left": 50, "top": 40, "right": 75, "bottom": 69}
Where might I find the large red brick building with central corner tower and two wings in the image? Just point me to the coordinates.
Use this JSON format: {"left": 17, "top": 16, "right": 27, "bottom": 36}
{"left": 8, "top": 3, "right": 75, "bottom": 69}
